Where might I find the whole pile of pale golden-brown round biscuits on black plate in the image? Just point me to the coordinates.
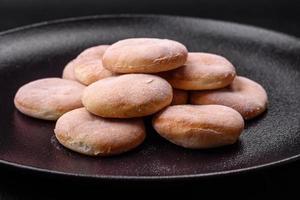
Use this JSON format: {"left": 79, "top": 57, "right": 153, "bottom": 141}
{"left": 14, "top": 38, "right": 268, "bottom": 156}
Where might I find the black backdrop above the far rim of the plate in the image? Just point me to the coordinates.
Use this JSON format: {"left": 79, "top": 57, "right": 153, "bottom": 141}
{"left": 0, "top": 0, "right": 300, "bottom": 37}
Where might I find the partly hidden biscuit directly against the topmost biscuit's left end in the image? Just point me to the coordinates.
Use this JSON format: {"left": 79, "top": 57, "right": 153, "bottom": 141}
{"left": 73, "top": 45, "right": 114, "bottom": 85}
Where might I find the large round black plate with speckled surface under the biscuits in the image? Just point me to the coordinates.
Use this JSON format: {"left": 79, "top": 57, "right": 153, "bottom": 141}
{"left": 0, "top": 16, "right": 300, "bottom": 179}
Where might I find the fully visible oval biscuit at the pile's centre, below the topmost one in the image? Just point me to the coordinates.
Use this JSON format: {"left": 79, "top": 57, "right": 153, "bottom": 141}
{"left": 82, "top": 74, "right": 172, "bottom": 118}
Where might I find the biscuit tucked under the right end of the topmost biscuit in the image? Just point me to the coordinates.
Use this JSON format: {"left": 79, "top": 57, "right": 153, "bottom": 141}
{"left": 161, "top": 53, "right": 235, "bottom": 90}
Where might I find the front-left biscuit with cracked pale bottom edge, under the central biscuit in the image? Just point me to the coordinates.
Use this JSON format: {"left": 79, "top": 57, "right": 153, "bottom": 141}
{"left": 54, "top": 108, "right": 146, "bottom": 156}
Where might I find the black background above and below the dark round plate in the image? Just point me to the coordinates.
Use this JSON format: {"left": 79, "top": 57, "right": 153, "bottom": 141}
{"left": 0, "top": 0, "right": 300, "bottom": 200}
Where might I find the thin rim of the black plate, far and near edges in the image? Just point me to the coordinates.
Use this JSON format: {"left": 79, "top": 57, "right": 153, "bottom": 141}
{"left": 0, "top": 14, "right": 300, "bottom": 181}
